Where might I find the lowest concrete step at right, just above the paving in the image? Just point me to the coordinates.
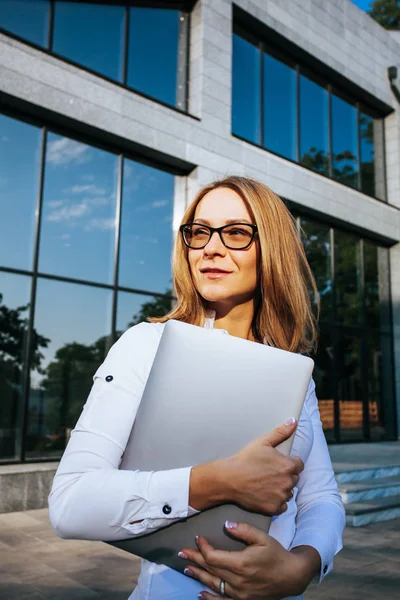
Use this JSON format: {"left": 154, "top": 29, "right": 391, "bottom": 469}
{"left": 345, "top": 494, "right": 400, "bottom": 527}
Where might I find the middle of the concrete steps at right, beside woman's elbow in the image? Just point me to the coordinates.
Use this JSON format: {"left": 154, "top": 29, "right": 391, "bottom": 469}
{"left": 338, "top": 476, "right": 400, "bottom": 504}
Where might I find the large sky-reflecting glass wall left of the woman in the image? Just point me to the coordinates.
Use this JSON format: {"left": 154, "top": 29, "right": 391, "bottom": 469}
{"left": 0, "top": 115, "right": 175, "bottom": 461}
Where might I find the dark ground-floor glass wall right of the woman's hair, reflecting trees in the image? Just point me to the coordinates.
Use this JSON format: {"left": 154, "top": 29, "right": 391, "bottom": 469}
{"left": 298, "top": 217, "right": 395, "bottom": 442}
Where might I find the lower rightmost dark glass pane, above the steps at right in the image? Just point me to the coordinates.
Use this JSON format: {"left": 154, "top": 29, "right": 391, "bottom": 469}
{"left": 367, "top": 333, "right": 396, "bottom": 441}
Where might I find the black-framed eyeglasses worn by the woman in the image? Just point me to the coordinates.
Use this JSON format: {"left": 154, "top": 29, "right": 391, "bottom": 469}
{"left": 179, "top": 223, "right": 257, "bottom": 250}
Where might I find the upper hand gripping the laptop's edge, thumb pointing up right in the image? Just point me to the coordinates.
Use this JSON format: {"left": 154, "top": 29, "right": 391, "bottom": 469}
{"left": 189, "top": 421, "right": 304, "bottom": 516}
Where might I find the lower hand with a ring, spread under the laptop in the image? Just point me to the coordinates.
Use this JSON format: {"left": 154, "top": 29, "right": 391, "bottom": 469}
{"left": 179, "top": 523, "right": 316, "bottom": 600}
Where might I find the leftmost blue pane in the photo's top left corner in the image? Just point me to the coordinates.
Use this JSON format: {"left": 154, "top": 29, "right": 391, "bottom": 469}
{"left": 0, "top": 0, "right": 50, "bottom": 48}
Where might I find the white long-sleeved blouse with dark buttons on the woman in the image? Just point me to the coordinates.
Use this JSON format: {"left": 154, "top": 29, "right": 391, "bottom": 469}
{"left": 49, "top": 318, "right": 345, "bottom": 600}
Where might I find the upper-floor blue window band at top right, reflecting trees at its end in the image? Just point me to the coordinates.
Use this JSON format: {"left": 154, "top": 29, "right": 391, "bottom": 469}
{"left": 232, "top": 30, "right": 386, "bottom": 200}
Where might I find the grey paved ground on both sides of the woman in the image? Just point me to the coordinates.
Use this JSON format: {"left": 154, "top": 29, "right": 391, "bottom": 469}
{"left": 0, "top": 509, "right": 400, "bottom": 600}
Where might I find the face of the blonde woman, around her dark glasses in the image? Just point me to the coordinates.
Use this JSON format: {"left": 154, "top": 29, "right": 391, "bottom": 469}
{"left": 189, "top": 188, "right": 259, "bottom": 308}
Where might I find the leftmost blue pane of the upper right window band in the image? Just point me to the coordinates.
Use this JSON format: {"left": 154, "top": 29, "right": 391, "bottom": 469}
{"left": 232, "top": 35, "right": 261, "bottom": 144}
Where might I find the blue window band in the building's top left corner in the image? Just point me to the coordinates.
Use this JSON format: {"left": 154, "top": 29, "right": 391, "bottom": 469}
{"left": 0, "top": 0, "right": 189, "bottom": 111}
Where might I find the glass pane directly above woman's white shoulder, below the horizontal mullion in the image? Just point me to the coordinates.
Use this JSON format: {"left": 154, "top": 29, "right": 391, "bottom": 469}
{"left": 117, "top": 292, "right": 173, "bottom": 336}
